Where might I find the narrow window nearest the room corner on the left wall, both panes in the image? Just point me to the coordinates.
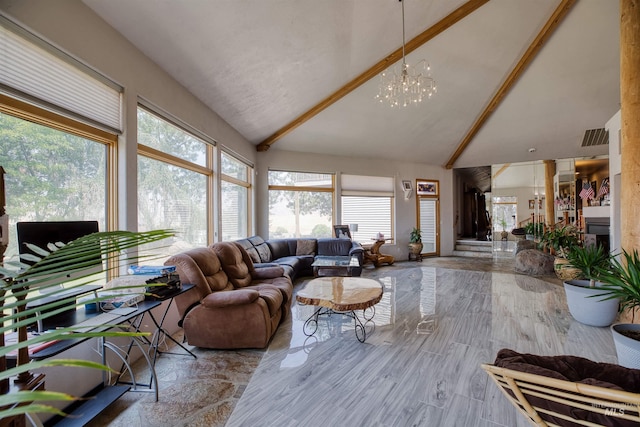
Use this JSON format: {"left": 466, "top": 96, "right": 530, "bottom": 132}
{"left": 220, "top": 151, "right": 253, "bottom": 241}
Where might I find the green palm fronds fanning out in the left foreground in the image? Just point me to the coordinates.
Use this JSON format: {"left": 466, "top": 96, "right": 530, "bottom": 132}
{"left": 0, "top": 230, "right": 174, "bottom": 419}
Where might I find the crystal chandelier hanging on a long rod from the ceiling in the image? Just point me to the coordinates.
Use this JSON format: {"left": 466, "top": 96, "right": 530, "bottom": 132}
{"left": 376, "top": 0, "right": 437, "bottom": 107}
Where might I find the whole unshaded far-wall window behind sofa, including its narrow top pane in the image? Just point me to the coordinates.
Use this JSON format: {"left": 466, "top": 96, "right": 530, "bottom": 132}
{"left": 269, "top": 171, "right": 334, "bottom": 239}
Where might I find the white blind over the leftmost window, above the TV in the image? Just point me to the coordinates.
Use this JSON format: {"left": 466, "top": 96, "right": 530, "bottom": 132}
{"left": 0, "top": 19, "right": 122, "bottom": 133}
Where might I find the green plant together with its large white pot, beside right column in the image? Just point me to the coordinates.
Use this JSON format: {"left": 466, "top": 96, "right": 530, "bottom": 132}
{"left": 564, "top": 245, "right": 619, "bottom": 327}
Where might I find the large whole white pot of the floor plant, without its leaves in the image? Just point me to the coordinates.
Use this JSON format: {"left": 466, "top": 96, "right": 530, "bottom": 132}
{"left": 564, "top": 280, "right": 620, "bottom": 327}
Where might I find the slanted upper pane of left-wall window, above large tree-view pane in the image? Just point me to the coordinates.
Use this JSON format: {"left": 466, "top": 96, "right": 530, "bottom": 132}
{"left": 138, "top": 108, "right": 207, "bottom": 166}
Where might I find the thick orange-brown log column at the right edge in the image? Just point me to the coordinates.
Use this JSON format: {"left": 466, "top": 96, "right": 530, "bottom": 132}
{"left": 620, "top": 0, "right": 640, "bottom": 251}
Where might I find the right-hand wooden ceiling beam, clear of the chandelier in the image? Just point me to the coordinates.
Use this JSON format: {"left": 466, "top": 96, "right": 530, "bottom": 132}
{"left": 445, "top": 0, "right": 576, "bottom": 169}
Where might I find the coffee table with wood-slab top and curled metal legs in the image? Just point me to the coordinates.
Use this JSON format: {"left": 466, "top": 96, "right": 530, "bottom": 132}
{"left": 296, "top": 277, "right": 382, "bottom": 342}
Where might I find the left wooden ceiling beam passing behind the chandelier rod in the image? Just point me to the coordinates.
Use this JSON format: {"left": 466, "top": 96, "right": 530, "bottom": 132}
{"left": 257, "top": 0, "right": 489, "bottom": 151}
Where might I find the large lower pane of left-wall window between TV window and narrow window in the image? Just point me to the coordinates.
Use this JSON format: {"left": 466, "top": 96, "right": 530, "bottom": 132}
{"left": 138, "top": 156, "right": 207, "bottom": 255}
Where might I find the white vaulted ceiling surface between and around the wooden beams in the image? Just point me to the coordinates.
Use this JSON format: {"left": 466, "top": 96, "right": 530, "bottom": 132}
{"left": 84, "top": 0, "right": 620, "bottom": 167}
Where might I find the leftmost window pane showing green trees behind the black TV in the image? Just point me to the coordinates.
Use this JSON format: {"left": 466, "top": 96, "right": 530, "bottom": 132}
{"left": 0, "top": 113, "right": 107, "bottom": 258}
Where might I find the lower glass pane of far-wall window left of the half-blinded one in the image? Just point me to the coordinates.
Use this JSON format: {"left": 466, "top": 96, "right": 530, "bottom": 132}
{"left": 269, "top": 190, "right": 333, "bottom": 239}
